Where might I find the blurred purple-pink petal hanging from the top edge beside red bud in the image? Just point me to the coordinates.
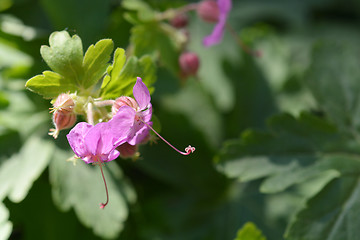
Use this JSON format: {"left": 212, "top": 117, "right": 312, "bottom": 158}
{"left": 203, "top": 0, "right": 232, "bottom": 47}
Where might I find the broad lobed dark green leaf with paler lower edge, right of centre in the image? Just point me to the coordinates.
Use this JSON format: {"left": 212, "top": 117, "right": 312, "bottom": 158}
{"left": 217, "top": 113, "right": 344, "bottom": 193}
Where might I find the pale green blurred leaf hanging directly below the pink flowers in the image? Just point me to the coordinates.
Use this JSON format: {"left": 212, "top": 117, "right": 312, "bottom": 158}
{"left": 50, "top": 151, "right": 136, "bottom": 238}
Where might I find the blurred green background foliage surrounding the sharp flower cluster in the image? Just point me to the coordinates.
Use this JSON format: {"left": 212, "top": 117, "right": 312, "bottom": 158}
{"left": 0, "top": 0, "right": 360, "bottom": 240}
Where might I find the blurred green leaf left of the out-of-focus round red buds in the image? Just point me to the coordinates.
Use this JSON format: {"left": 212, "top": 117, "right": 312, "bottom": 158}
{"left": 130, "top": 22, "right": 185, "bottom": 73}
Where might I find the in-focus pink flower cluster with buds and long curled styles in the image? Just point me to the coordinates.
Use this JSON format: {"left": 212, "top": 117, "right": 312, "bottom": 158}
{"left": 53, "top": 77, "right": 195, "bottom": 208}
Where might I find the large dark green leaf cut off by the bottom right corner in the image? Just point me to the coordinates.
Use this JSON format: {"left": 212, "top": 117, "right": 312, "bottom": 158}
{"left": 285, "top": 159, "right": 360, "bottom": 240}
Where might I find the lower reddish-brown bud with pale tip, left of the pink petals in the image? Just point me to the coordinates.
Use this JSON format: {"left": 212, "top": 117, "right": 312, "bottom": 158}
{"left": 49, "top": 111, "right": 76, "bottom": 139}
